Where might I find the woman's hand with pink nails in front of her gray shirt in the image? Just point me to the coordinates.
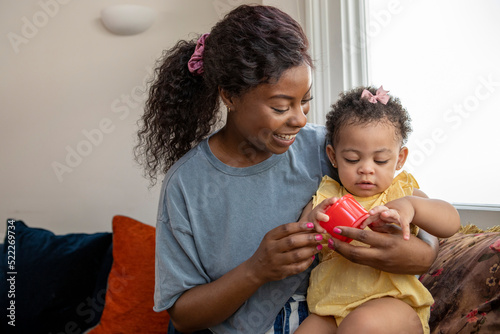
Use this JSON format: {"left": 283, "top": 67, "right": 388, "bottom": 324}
{"left": 246, "top": 222, "right": 324, "bottom": 285}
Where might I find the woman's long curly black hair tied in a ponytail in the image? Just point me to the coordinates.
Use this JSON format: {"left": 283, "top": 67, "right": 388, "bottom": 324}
{"left": 134, "top": 5, "right": 313, "bottom": 185}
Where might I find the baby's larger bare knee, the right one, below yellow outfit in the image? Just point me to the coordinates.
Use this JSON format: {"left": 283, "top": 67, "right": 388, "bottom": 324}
{"left": 337, "top": 297, "right": 423, "bottom": 334}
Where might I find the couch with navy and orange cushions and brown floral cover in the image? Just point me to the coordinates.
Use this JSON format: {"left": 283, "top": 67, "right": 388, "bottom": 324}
{"left": 0, "top": 216, "right": 500, "bottom": 334}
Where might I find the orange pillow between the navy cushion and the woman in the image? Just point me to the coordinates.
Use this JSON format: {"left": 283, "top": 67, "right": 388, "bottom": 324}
{"left": 88, "top": 216, "right": 170, "bottom": 334}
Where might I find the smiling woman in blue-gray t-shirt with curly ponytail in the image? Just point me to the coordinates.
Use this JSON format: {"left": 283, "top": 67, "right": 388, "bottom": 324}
{"left": 136, "top": 6, "right": 437, "bottom": 333}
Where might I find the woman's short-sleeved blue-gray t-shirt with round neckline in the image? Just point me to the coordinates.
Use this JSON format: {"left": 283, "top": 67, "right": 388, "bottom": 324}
{"left": 154, "top": 124, "right": 330, "bottom": 334}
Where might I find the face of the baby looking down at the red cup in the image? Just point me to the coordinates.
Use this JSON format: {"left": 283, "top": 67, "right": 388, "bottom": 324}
{"left": 327, "top": 120, "right": 408, "bottom": 197}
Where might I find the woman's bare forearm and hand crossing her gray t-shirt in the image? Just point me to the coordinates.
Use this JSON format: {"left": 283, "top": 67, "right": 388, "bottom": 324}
{"left": 168, "top": 222, "right": 320, "bottom": 332}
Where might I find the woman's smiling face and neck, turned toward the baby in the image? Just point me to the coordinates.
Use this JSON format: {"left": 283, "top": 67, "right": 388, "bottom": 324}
{"left": 214, "top": 65, "right": 311, "bottom": 167}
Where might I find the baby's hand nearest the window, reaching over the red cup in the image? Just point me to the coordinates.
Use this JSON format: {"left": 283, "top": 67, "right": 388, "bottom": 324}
{"left": 360, "top": 199, "right": 415, "bottom": 240}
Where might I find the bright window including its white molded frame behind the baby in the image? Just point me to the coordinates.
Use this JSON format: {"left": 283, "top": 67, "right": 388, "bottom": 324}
{"left": 274, "top": 0, "right": 500, "bottom": 207}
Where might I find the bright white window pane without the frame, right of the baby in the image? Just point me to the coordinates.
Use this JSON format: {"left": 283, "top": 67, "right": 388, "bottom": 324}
{"left": 365, "top": 0, "right": 500, "bottom": 207}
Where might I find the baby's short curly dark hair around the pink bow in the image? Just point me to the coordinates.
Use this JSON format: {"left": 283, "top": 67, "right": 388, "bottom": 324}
{"left": 326, "top": 86, "right": 412, "bottom": 146}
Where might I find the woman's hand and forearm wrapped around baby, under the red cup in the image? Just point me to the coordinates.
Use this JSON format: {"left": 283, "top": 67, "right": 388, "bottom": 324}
{"left": 328, "top": 225, "right": 439, "bottom": 275}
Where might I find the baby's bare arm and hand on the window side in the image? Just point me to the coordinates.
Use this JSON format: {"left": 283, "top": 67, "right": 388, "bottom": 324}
{"left": 363, "top": 189, "right": 460, "bottom": 239}
